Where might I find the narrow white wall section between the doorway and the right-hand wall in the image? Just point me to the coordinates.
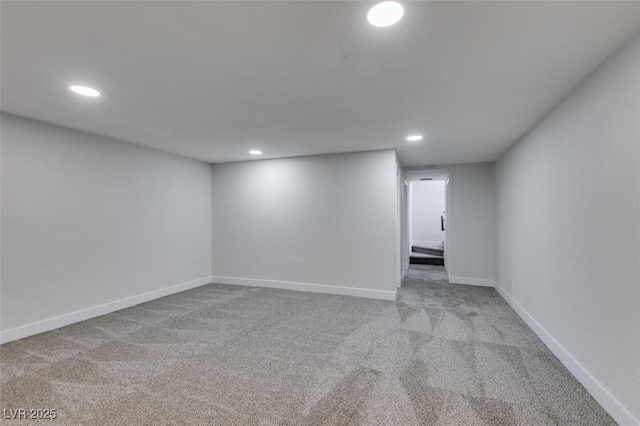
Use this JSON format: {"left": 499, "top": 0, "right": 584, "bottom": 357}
{"left": 445, "top": 163, "right": 496, "bottom": 286}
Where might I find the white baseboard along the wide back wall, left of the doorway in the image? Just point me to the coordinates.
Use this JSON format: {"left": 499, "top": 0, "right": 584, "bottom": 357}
{"left": 211, "top": 276, "right": 396, "bottom": 300}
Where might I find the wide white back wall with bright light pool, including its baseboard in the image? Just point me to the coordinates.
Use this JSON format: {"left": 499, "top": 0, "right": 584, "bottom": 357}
{"left": 213, "top": 150, "right": 397, "bottom": 299}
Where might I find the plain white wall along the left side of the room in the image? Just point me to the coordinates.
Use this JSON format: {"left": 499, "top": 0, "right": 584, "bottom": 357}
{"left": 0, "top": 114, "right": 211, "bottom": 338}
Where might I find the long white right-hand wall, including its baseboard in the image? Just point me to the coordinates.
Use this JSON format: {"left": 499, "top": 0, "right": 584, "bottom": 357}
{"left": 496, "top": 37, "right": 640, "bottom": 425}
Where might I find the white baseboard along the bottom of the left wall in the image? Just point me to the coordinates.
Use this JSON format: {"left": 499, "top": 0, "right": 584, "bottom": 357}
{"left": 0, "top": 277, "right": 211, "bottom": 344}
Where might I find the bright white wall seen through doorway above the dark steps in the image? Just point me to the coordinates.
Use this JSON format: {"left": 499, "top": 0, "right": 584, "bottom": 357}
{"left": 411, "top": 180, "right": 445, "bottom": 247}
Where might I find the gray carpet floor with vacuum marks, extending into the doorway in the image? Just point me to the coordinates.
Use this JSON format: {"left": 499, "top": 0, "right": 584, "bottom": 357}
{"left": 0, "top": 265, "right": 615, "bottom": 425}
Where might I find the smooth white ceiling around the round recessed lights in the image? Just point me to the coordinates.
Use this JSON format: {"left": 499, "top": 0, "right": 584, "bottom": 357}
{"left": 1, "top": 1, "right": 640, "bottom": 166}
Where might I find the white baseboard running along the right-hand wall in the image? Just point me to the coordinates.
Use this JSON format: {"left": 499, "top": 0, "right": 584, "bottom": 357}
{"left": 495, "top": 283, "right": 640, "bottom": 426}
